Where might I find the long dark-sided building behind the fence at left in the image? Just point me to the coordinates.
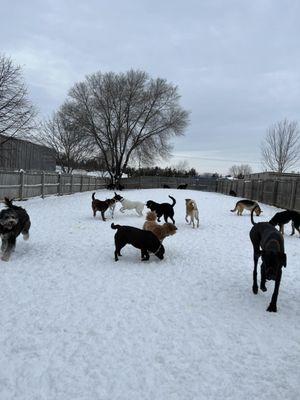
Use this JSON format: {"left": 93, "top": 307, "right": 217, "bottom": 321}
{"left": 0, "top": 135, "right": 56, "bottom": 171}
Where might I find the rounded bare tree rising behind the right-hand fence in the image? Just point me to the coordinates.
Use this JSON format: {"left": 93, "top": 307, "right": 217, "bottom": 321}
{"left": 262, "top": 118, "right": 300, "bottom": 173}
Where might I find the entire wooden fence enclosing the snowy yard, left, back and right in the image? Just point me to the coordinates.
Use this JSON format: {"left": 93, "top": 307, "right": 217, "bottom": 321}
{"left": 0, "top": 171, "right": 300, "bottom": 211}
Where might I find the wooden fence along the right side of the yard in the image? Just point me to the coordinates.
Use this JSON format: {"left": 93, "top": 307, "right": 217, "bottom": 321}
{"left": 217, "top": 178, "right": 300, "bottom": 211}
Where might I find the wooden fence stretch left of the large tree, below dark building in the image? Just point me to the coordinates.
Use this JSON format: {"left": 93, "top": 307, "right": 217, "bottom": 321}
{"left": 0, "top": 171, "right": 106, "bottom": 200}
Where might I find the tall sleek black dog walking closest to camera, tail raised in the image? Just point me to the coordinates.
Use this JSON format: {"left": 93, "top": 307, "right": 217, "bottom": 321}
{"left": 250, "top": 209, "right": 286, "bottom": 312}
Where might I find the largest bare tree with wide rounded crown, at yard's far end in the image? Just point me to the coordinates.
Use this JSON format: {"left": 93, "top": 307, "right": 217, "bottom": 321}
{"left": 67, "top": 70, "right": 188, "bottom": 182}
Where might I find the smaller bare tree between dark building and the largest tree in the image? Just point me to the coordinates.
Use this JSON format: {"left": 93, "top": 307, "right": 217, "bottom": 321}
{"left": 36, "top": 105, "right": 92, "bottom": 173}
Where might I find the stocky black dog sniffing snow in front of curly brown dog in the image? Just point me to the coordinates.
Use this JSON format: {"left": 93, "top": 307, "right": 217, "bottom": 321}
{"left": 111, "top": 224, "right": 165, "bottom": 261}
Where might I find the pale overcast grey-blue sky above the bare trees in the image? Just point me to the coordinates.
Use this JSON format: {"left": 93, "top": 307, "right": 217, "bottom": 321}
{"left": 0, "top": 0, "right": 300, "bottom": 173}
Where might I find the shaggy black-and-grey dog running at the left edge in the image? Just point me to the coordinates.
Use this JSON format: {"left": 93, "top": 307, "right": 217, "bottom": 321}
{"left": 0, "top": 197, "right": 31, "bottom": 261}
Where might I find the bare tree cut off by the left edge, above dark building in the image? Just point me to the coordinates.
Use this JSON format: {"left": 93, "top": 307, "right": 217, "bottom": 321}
{"left": 0, "top": 54, "right": 36, "bottom": 146}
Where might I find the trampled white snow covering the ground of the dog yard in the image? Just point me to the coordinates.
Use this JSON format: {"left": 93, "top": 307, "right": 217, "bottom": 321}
{"left": 0, "top": 189, "right": 300, "bottom": 400}
